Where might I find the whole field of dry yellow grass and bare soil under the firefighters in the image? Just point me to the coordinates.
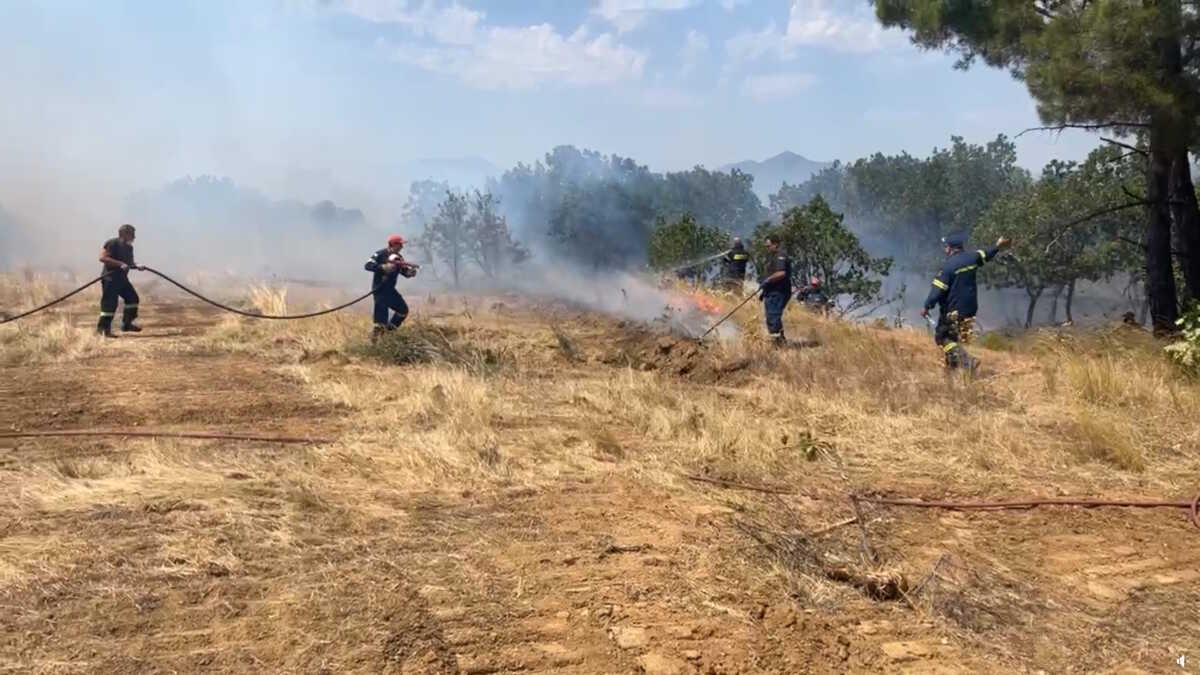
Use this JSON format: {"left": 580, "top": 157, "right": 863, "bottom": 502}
{"left": 0, "top": 270, "right": 1200, "bottom": 674}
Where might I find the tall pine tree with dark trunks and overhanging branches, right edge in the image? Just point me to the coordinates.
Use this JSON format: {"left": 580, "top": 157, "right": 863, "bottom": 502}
{"left": 875, "top": 0, "right": 1200, "bottom": 330}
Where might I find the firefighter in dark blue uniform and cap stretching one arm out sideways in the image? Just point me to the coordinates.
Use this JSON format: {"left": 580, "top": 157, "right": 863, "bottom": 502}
{"left": 920, "top": 234, "right": 1010, "bottom": 372}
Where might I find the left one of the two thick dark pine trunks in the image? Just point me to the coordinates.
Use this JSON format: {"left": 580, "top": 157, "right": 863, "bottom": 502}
{"left": 1146, "top": 112, "right": 1178, "bottom": 333}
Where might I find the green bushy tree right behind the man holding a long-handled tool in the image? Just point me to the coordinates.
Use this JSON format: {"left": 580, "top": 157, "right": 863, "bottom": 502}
{"left": 751, "top": 196, "right": 892, "bottom": 311}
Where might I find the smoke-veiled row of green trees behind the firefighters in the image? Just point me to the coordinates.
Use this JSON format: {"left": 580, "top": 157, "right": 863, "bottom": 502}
{"left": 406, "top": 136, "right": 1148, "bottom": 325}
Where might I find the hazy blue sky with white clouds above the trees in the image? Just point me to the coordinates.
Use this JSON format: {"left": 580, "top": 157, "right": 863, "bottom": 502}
{"left": 0, "top": 0, "right": 1096, "bottom": 225}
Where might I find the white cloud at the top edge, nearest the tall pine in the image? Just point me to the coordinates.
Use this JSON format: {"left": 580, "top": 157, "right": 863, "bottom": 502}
{"left": 726, "top": 0, "right": 905, "bottom": 60}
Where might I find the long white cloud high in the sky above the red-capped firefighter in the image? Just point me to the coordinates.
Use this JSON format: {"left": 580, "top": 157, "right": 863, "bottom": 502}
{"left": 326, "top": 0, "right": 646, "bottom": 89}
